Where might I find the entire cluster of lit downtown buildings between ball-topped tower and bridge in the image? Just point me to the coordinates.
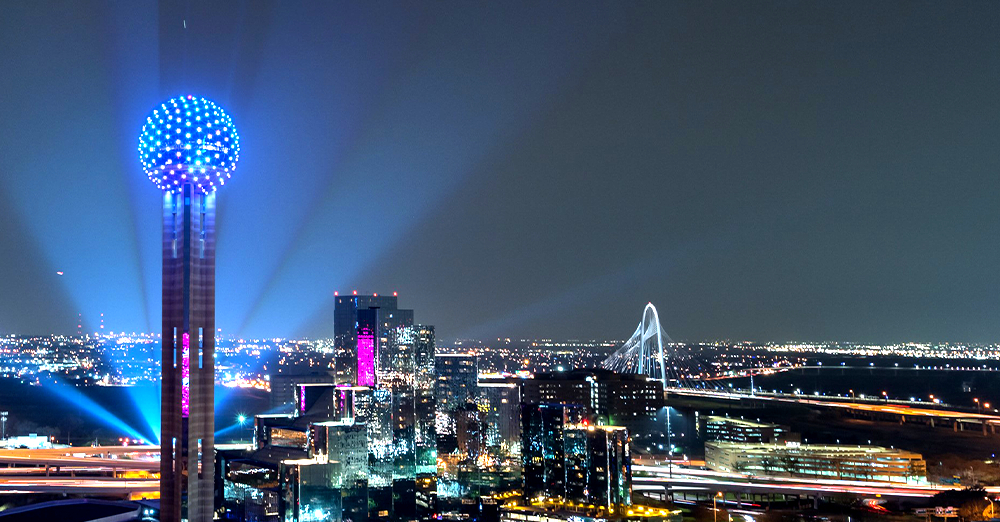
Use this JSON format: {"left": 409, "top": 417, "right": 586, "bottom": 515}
{"left": 216, "top": 295, "right": 648, "bottom": 522}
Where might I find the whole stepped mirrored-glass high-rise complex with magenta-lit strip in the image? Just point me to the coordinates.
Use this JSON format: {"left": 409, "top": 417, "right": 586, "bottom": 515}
{"left": 218, "top": 295, "right": 437, "bottom": 522}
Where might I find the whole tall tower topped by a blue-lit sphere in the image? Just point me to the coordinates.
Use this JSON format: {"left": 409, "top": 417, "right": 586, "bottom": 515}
{"left": 139, "top": 95, "right": 240, "bottom": 522}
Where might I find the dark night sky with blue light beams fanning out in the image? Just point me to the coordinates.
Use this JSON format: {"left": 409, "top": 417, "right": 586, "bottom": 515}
{"left": 0, "top": 0, "right": 1000, "bottom": 342}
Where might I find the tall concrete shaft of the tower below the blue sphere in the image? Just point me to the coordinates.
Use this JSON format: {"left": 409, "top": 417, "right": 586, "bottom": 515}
{"left": 160, "top": 183, "right": 215, "bottom": 522}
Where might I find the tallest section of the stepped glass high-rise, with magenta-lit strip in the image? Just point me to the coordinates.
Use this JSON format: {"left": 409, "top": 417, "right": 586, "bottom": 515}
{"left": 334, "top": 295, "right": 436, "bottom": 521}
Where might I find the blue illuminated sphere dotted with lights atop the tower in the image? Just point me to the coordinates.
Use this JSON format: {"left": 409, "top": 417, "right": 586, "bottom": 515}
{"left": 139, "top": 95, "right": 240, "bottom": 194}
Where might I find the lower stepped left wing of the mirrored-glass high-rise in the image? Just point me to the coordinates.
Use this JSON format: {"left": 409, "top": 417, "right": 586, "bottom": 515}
{"left": 217, "top": 384, "right": 369, "bottom": 522}
